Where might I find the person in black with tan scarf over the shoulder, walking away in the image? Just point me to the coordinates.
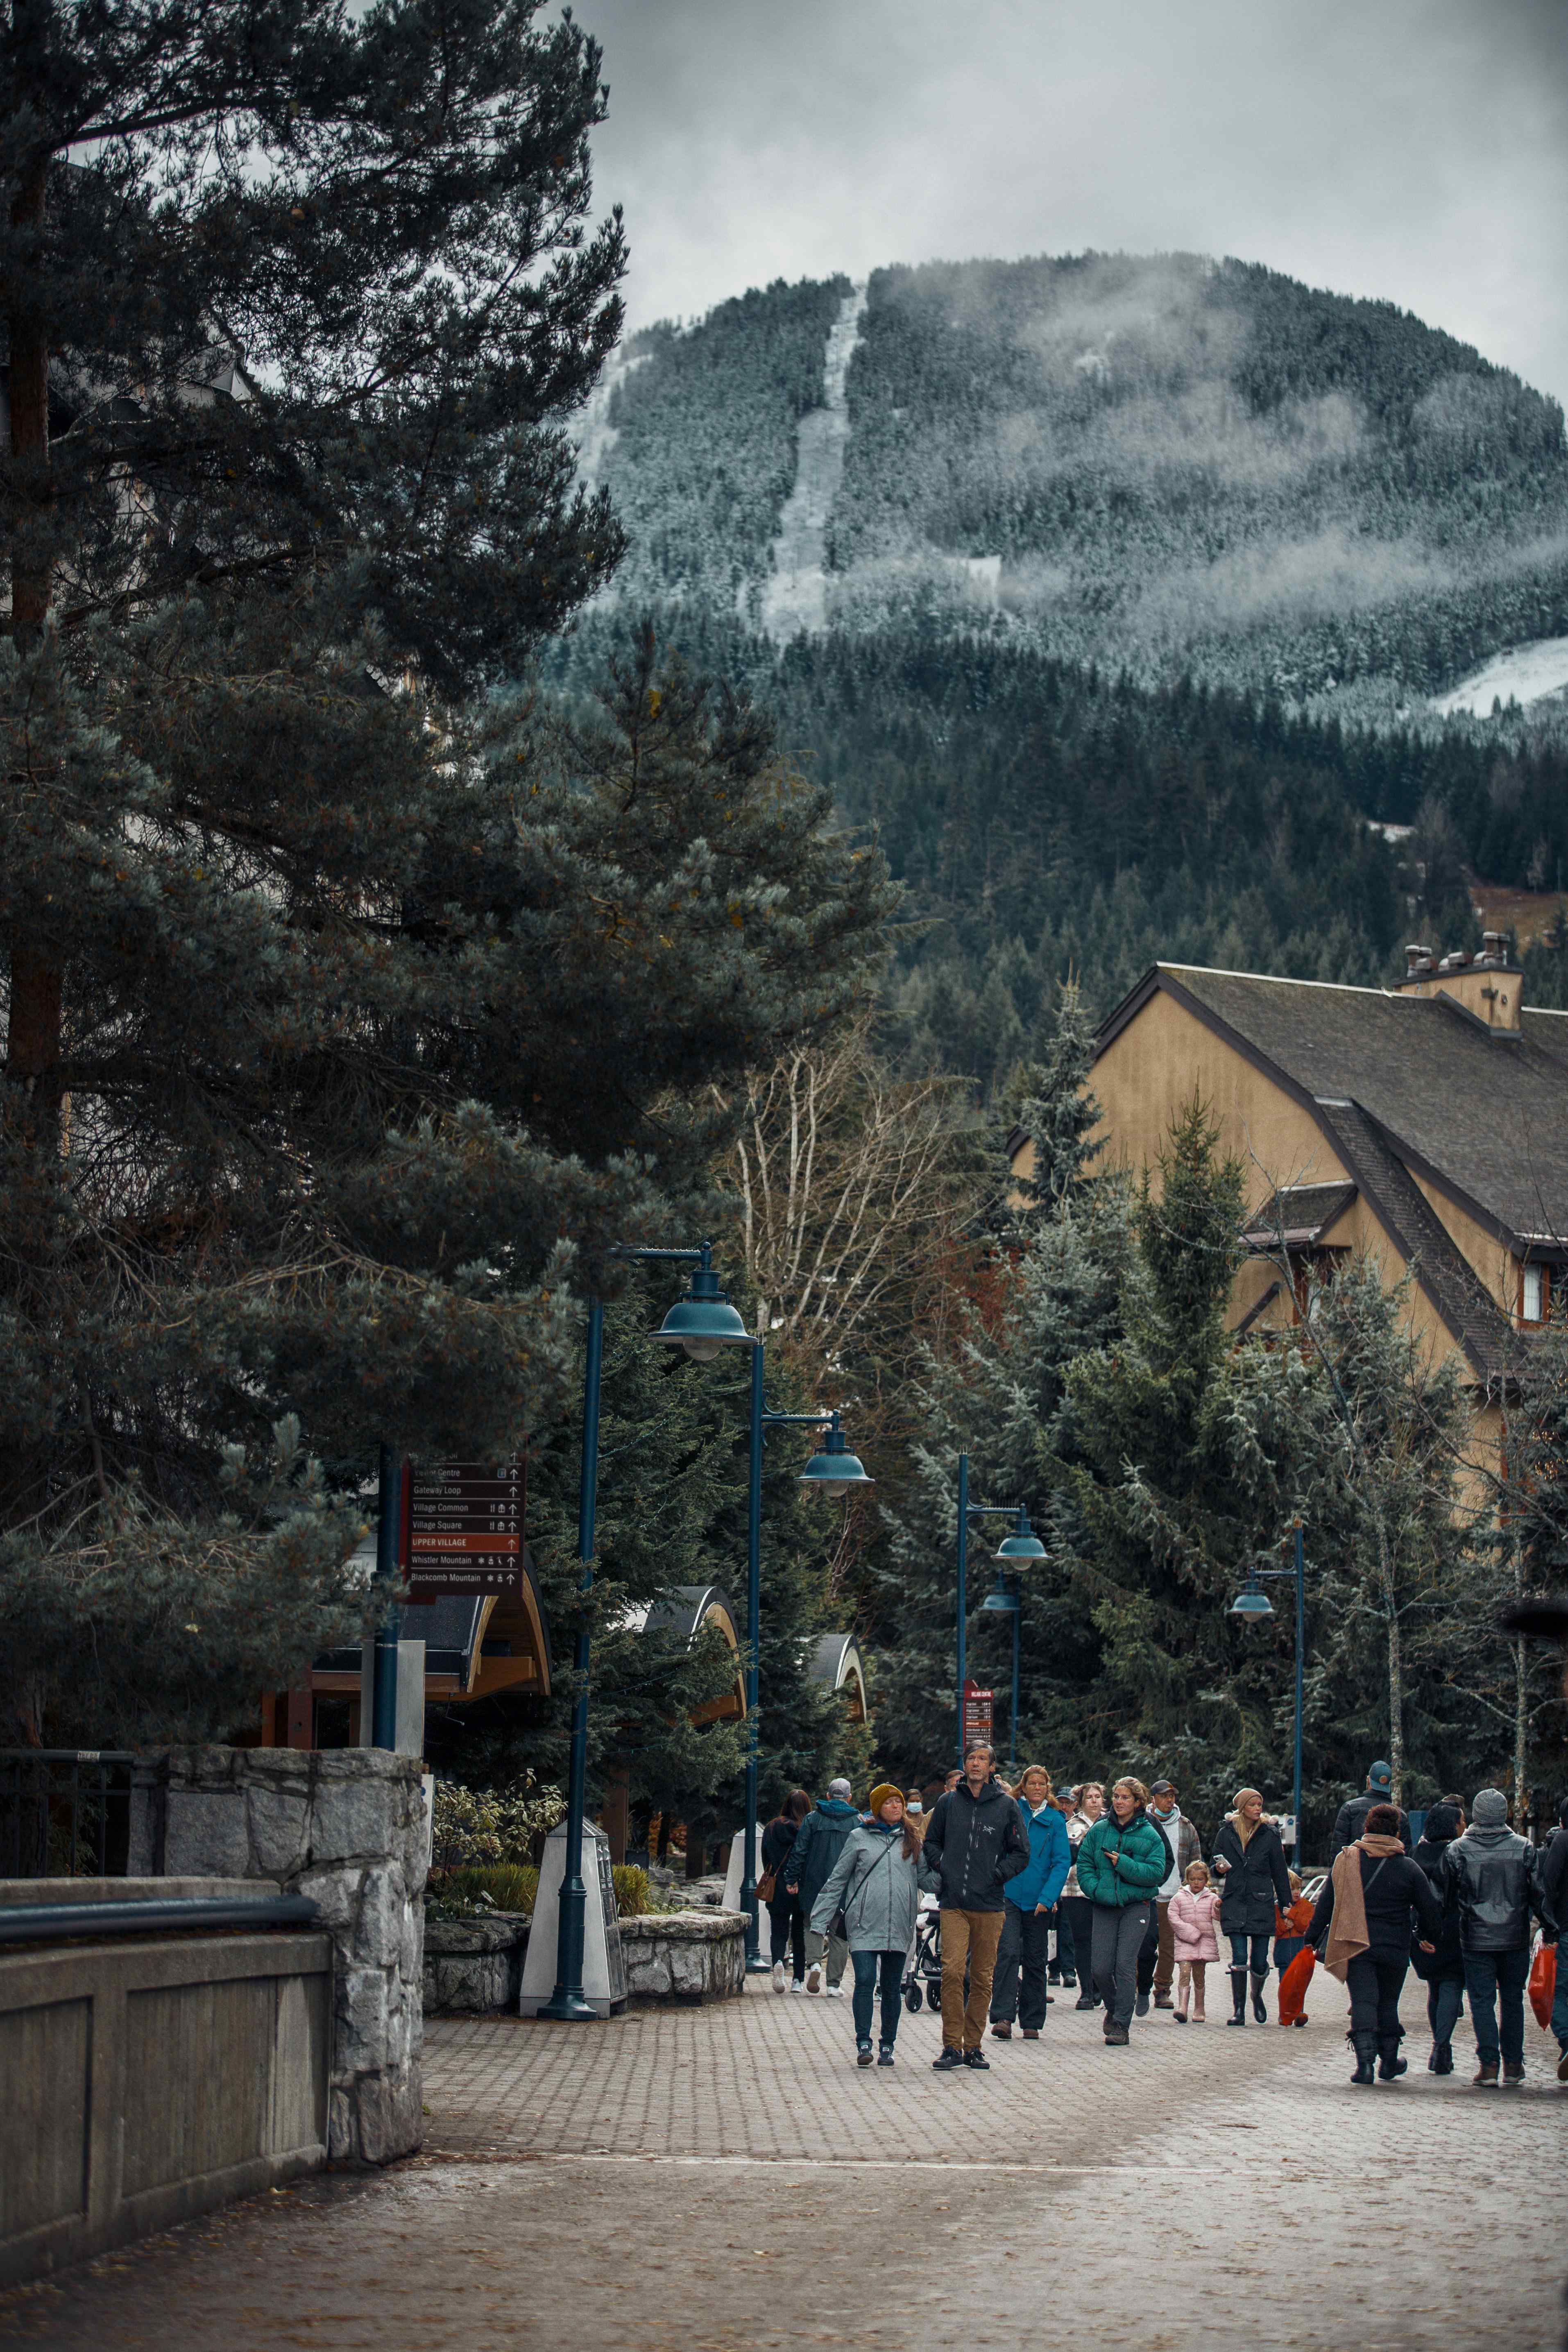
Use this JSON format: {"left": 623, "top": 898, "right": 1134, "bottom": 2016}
{"left": 1307, "top": 1804, "right": 1443, "bottom": 2084}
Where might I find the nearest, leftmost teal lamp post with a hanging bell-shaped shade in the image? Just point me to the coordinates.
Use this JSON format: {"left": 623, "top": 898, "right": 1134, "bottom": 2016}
{"left": 538, "top": 1242, "right": 750, "bottom": 2023}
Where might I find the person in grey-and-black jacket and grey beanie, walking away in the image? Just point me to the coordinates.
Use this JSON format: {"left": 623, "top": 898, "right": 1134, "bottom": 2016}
{"left": 1443, "top": 1788, "right": 1556, "bottom": 2084}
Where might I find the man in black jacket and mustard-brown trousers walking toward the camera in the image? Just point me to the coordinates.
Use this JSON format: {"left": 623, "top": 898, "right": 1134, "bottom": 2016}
{"left": 922, "top": 1740, "right": 1030, "bottom": 2072}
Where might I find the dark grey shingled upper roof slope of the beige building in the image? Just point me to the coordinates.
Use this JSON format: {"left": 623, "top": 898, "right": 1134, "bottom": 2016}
{"left": 1142, "top": 964, "right": 1568, "bottom": 1244}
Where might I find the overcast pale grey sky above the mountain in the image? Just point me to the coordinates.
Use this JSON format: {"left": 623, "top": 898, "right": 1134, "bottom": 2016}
{"left": 576, "top": 0, "right": 1568, "bottom": 400}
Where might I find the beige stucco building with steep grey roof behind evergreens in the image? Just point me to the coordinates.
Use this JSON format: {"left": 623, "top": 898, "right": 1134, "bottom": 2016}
{"left": 1011, "top": 934, "right": 1568, "bottom": 1446}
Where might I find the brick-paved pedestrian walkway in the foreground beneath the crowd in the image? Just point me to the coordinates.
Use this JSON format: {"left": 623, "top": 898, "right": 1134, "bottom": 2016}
{"left": 0, "top": 1987, "right": 1568, "bottom": 2352}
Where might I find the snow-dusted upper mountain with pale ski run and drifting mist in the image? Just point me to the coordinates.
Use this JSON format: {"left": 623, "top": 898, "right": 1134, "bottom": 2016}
{"left": 583, "top": 254, "right": 1568, "bottom": 713}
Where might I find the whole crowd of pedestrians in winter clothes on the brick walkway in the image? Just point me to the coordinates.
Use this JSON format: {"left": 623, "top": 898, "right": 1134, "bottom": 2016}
{"left": 757, "top": 1740, "right": 1568, "bottom": 2086}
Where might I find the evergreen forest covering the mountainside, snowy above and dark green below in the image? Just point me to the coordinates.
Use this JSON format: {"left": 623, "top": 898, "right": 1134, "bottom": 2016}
{"left": 562, "top": 254, "right": 1568, "bottom": 1089}
